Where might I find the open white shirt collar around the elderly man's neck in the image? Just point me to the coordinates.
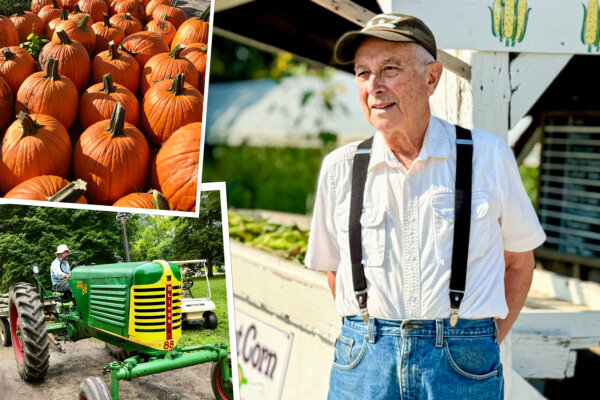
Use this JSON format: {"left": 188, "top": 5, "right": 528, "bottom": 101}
{"left": 369, "top": 115, "right": 450, "bottom": 170}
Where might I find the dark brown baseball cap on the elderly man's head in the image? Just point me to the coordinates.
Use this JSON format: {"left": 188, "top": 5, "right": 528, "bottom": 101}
{"left": 333, "top": 14, "right": 437, "bottom": 64}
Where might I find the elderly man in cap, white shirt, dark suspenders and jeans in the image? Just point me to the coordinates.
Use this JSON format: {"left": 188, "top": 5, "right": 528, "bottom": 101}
{"left": 306, "top": 14, "right": 545, "bottom": 400}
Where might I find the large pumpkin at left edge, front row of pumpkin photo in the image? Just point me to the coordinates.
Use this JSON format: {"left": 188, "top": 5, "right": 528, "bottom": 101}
{"left": 0, "top": 112, "right": 71, "bottom": 193}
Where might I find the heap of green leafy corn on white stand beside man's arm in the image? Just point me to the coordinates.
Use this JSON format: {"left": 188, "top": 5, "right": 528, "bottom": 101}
{"left": 229, "top": 211, "right": 308, "bottom": 264}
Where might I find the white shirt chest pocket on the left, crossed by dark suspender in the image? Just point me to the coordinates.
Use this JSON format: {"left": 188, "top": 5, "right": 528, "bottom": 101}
{"left": 335, "top": 208, "right": 387, "bottom": 267}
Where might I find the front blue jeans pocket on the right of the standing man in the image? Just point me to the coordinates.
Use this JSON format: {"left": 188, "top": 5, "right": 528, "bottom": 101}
{"left": 444, "top": 336, "right": 501, "bottom": 380}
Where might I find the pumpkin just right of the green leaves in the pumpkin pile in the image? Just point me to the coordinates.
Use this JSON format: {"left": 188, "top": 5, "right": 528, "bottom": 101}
{"left": 39, "top": 28, "right": 92, "bottom": 93}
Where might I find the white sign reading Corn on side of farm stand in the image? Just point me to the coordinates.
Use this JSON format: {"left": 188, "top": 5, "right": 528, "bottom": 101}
{"left": 235, "top": 310, "right": 294, "bottom": 400}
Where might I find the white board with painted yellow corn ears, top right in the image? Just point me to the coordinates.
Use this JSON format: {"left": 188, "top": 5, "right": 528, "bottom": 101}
{"left": 392, "top": 0, "right": 600, "bottom": 55}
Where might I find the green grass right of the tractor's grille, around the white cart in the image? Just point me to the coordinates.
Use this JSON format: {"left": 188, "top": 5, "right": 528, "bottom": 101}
{"left": 179, "top": 275, "right": 229, "bottom": 347}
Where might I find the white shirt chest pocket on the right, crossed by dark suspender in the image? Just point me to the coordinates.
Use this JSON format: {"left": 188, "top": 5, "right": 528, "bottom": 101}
{"left": 431, "top": 191, "right": 491, "bottom": 267}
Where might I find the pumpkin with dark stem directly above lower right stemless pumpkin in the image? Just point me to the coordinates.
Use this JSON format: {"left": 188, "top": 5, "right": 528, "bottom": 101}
{"left": 142, "top": 74, "right": 204, "bottom": 144}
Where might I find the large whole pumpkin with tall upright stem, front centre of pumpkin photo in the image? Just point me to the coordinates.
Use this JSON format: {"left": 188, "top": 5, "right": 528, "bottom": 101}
{"left": 73, "top": 103, "right": 150, "bottom": 204}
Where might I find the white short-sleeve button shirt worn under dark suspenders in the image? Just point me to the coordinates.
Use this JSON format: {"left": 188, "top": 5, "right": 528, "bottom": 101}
{"left": 305, "top": 117, "right": 546, "bottom": 319}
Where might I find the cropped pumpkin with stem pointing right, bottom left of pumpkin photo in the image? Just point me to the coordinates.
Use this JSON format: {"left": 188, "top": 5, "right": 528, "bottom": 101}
{"left": 4, "top": 175, "right": 87, "bottom": 204}
